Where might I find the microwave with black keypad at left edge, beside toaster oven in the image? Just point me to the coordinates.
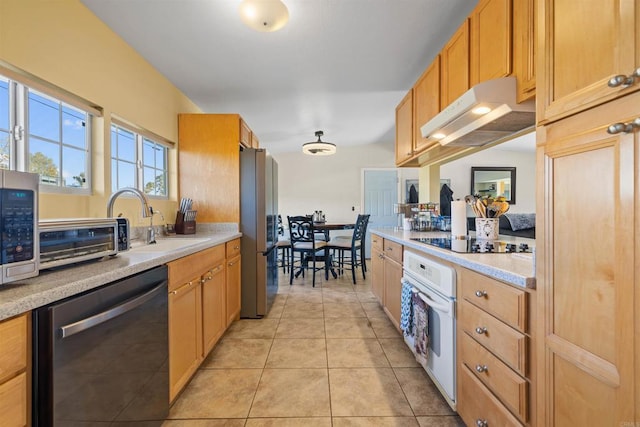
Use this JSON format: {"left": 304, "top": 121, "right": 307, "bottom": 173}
{"left": 0, "top": 170, "right": 40, "bottom": 284}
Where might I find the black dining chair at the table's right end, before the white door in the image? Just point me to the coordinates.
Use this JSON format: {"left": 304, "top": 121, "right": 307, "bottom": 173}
{"left": 328, "top": 214, "right": 370, "bottom": 285}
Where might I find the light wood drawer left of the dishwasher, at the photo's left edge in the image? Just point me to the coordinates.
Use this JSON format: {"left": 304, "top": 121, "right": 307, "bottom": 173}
{"left": 0, "top": 314, "right": 28, "bottom": 382}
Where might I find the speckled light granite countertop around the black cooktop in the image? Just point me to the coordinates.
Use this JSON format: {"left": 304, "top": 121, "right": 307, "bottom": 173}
{"left": 371, "top": 227, "right": 536, "bottom": 289}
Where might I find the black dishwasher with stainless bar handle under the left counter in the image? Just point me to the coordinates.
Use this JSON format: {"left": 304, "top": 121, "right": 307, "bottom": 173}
{"left": 33, "top": 266, "right": 169, "bottom": 427}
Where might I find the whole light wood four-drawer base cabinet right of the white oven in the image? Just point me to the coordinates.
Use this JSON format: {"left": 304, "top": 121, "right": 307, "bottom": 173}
{"left": 456, "top": 267, "right": 537, "bottom": 426}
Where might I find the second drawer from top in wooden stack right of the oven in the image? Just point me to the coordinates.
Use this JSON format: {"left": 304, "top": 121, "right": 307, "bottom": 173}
{"left": 460, "top": 300, "right": 527, "bottom": 376}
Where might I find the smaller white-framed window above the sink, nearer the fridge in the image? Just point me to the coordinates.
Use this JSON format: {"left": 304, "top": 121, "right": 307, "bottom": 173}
{"left": 111, "top": 123, "right": 169, "bottom": 198}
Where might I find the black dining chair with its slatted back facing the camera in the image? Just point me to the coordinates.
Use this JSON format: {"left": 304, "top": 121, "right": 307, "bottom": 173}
{"left": 287, "top": 216, "right": 330, "bottom": 287}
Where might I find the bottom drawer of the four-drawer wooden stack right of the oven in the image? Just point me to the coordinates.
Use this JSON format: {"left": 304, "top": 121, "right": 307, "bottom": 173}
{"left": 457, "top": 365, "right": 522, "bottom": 426}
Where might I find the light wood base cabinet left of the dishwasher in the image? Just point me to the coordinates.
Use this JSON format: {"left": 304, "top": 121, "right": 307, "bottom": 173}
{"left": 0, "top": 313, "right": 31, "bottom": 426}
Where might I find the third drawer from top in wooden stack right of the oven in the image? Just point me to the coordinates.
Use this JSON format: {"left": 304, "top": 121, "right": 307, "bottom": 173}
{"left": 459, "top": 334, "right": 529, "bottom": 422}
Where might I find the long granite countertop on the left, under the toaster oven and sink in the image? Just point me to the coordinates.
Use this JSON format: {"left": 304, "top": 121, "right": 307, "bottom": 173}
{"left": 0, "top": 231, "right": 241, "bottom": 320}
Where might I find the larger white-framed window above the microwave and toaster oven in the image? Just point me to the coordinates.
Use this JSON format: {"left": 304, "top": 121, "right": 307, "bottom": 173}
{"left": 0, "top": 76, "right": 93, "bottom": 193}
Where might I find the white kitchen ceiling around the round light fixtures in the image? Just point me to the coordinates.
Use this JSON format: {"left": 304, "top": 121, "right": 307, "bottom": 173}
{"left": 82, "top": 0, "right": 477, "bottom": 153}
